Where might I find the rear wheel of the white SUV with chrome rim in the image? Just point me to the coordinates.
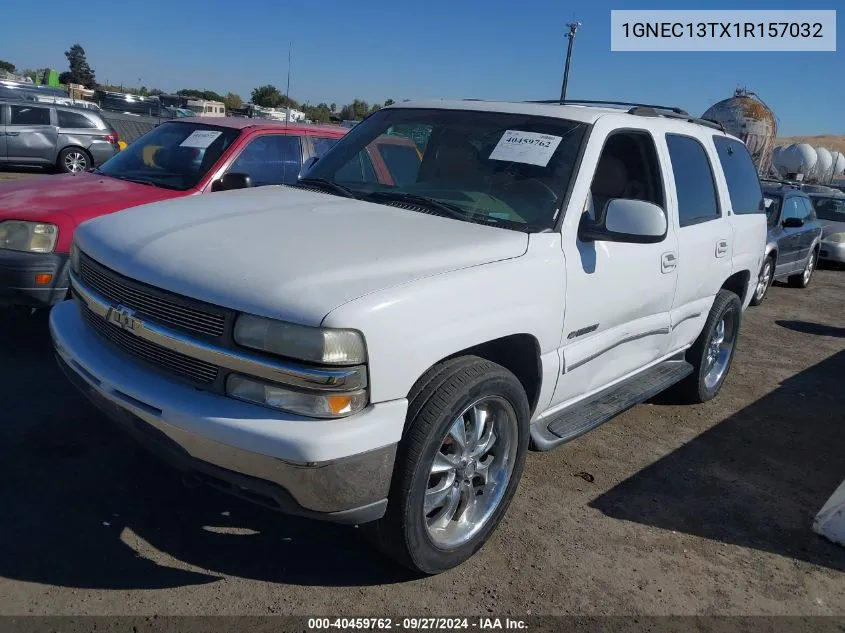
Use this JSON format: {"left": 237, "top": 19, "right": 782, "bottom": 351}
{"left": 678, "top": 290, "right": 742, "bottom": 403}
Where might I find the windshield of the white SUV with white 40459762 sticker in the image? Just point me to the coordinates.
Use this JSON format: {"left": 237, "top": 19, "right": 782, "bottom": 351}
{"left": 308, "top": 108, "right": 587, "bottom": 231}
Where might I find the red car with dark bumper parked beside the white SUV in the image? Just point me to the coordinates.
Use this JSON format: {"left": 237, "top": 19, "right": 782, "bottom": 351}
{"left": 0, "top": 117, "right": 349, "bottom": 308}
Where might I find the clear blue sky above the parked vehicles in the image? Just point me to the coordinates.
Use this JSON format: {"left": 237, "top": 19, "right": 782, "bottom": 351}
{"left": 0, "top": 0, "right": 845, "bottom": 135}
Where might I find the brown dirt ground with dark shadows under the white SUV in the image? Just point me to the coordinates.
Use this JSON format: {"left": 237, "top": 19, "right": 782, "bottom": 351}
{"left": 0, "top": 177, "right": 845, "bottom": 616}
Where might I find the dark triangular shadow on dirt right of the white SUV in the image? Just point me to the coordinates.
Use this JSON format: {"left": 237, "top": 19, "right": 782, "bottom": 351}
{"left": 590, "top": 348, "right": 845, "bottom": 571}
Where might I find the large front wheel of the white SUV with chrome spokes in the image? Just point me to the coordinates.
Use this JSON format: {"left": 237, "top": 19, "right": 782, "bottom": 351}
{"left": 361, "top": 356, "right": 530, "bottom": 574}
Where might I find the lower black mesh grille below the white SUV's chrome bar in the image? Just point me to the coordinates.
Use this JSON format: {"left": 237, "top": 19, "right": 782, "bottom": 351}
{"left": 79, "top": 302, "right": 218, "bottom": 384}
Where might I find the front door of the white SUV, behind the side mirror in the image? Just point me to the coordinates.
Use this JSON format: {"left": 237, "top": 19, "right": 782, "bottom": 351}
{"left": 550, "top": 124, "right": 678, "bottom": 406}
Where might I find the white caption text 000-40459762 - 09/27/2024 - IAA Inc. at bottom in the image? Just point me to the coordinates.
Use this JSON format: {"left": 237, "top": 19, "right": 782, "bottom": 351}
{"left": 308, "top": 617, "right": 528, "bottom": 631}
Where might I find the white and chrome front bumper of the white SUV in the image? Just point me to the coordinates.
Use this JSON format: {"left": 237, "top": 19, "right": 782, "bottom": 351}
{"left": 50, "top": 301, "right": 407, "bottom": 523}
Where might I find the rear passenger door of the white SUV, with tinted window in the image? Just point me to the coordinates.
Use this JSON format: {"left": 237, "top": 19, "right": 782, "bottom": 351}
{"left": 663, "top": 132, "right": 733, "bottom": 350}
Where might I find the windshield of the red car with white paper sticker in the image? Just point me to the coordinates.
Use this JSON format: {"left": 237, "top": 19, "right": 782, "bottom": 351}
{"left": 99, "top": 122, "right": 240, "bottom": 191}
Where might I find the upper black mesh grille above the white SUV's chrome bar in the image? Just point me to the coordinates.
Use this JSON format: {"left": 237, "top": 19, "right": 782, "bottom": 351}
{"left": 79, "top": 254, "right": 226, "bottom": 337}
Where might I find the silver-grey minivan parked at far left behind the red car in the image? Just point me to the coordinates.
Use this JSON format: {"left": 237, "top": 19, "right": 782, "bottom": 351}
{"left": 0, "top": 100, "right": 119, "bottom": 173}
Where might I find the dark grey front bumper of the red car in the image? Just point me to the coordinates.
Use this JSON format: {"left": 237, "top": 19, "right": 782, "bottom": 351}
{"left": 0, "top": 248, "right": 69, "bottom": 308}
